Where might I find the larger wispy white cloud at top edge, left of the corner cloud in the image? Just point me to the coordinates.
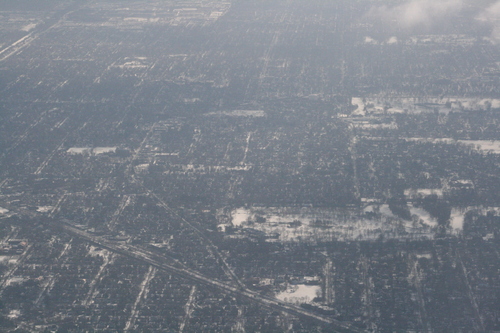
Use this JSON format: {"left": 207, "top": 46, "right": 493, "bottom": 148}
{"left": 368, "top": 0, "right": 464, "bottom": 29}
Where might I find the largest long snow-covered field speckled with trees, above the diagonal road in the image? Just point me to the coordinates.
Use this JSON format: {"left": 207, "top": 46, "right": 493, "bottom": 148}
{"left": 223, "top": 204, "right": 442, "bottom": 242}
